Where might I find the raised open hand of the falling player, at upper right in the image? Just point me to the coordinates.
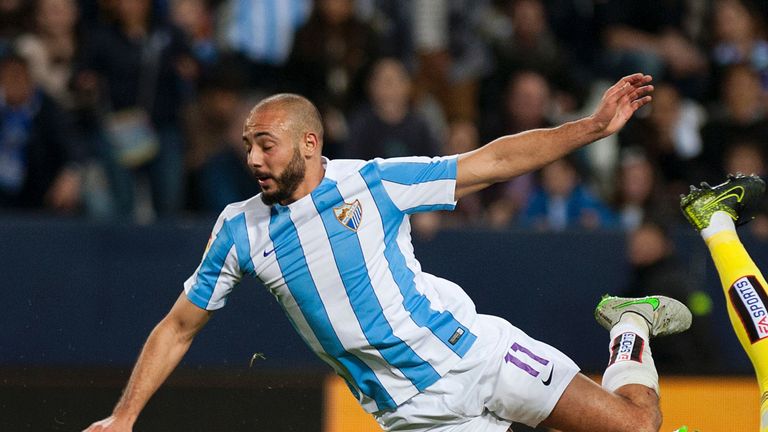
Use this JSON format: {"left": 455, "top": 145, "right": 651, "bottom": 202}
{"left": 592, "top": 73, "right": 653, "bottom": 136}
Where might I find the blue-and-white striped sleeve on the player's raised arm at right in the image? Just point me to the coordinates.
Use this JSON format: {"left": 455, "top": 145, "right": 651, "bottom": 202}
{"left": 375, "top": 156, "right": 457, "bottom": 214}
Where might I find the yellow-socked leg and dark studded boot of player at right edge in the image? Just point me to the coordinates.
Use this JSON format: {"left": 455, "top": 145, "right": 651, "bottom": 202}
{"left": 680, "top": 175, "right": 768, "bottom": 432}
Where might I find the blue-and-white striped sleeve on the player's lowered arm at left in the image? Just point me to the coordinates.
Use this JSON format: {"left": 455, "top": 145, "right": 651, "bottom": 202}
{"left": 184, "top": 214, "right": 243, "bottom": 310}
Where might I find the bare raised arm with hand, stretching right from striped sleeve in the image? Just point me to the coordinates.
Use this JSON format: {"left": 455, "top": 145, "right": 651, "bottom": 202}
{"left": 455, "top": 73, "right": 653, "bottom": 199}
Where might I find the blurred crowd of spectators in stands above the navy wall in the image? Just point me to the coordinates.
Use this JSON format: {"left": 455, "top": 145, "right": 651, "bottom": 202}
{"left": 0, "top": 0, "right": 768, "bottom": 236}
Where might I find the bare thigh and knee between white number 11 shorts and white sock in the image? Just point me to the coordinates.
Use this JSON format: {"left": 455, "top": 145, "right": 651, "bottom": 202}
{"left": 542, "top": 373, "right": 661, "bottom": 432}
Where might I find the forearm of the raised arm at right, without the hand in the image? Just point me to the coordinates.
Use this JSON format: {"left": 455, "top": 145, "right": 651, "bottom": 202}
{"left": 488, "top": 117, "right": 605, "bottom": 182}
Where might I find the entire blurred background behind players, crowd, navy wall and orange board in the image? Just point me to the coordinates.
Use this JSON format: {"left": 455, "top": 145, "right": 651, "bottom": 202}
{"left": 0, "top": 0, "right": 768, "bottom": 432}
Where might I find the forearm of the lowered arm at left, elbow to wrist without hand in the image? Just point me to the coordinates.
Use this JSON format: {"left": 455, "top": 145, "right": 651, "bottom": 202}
{"left": 113, "top": 320, "right": 192, "bottom": 423}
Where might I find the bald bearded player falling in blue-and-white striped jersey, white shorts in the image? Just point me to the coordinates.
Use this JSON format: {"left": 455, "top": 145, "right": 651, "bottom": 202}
{"left": 87, "top": 74, "right": 691, "bottom": 432}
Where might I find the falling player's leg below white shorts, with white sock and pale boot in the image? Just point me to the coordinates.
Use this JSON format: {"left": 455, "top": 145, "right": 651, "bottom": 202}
{"left": 542, "top": 296, "right": 691, "bottom": 432}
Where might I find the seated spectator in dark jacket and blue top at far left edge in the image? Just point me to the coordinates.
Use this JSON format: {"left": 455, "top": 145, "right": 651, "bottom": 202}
{"left": 0, "top": 54, "right": 85, "bottom": 213}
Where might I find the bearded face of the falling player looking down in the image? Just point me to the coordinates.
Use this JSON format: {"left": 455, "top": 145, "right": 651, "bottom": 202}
{"left": 243, "top": 109, "right": 306, "bottom": 205}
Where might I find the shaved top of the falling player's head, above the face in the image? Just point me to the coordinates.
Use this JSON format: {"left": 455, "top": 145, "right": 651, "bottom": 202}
{"left": 246, "top": 93, "right": 323, "bottom": 142}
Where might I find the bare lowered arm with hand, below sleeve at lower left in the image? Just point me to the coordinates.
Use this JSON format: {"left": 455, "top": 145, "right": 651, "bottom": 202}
{"left": 84, "top": 293, "right": 211, "bottom": 432}
